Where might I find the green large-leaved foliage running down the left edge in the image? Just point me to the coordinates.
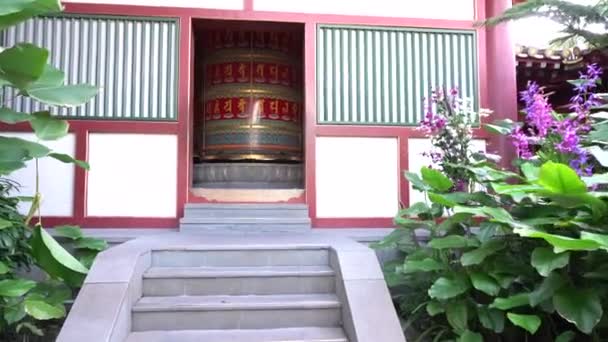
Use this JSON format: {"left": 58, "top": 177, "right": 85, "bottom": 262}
{"left": 0, "top": 0, "right": 106, "bottom": 341}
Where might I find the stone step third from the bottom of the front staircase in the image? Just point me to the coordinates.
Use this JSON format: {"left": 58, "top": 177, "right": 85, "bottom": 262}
{"left": 143, "top": 266, "right": 335, "bottom": 296}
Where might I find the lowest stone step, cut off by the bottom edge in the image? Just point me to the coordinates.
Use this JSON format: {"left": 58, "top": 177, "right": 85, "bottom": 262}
{"left": 126, "top": 327, "right": 348, "bottom": 342}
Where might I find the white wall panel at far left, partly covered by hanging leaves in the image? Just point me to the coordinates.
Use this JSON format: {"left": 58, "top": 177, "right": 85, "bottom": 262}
{"left": 2, "top": 132, "right": 76, "bottom": 216}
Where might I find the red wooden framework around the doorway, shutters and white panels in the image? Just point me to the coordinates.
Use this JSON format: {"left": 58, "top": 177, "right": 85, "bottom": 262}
{"left": 0, "top": 0, "right": 516, "bottom": 228}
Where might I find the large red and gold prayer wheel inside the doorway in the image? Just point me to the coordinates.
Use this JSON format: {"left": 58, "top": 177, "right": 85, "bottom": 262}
{"left": 202, "top": 31, "right": 302, "bottom": 161}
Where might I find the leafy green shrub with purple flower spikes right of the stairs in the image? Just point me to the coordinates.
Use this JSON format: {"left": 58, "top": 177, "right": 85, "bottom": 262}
{"left": 375, "top": 66, "right": 608, "bottom": 342}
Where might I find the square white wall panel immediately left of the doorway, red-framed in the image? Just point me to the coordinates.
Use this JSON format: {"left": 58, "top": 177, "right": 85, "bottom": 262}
{"left": 87, "top": 133, "right": 177, "bottom": 217}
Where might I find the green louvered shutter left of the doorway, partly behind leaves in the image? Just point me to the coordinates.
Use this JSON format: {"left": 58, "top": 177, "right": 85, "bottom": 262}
{"left": 0, "top": 14, "right": 179, "bottom": 121}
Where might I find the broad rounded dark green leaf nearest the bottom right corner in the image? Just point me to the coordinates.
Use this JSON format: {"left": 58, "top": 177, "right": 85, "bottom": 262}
{"left": 553, "top": 287, "right": 603, "bottom": 334}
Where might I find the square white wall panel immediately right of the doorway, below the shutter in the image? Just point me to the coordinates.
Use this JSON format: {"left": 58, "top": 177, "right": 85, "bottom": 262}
{"left": 316, "top": 137, "right": 399, "bottom": 218}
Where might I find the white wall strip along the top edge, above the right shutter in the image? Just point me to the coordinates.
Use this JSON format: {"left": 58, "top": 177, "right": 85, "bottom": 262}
{"left": 253, "top": 0, "right": 475, "bottom": 20}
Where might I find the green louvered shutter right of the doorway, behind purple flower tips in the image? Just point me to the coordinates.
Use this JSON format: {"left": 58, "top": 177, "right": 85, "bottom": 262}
{"left": 317, "top": 25, "right": 478, "bottom": 125}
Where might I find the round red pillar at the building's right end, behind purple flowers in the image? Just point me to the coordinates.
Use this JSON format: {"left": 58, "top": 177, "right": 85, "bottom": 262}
{"left": 481, "top": 0, "right": 518, "bottom": 167}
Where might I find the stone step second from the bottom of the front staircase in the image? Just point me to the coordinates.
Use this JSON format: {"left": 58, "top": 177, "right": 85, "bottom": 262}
{"left": 132, "top": 294, "right": 341, "bottom": 331}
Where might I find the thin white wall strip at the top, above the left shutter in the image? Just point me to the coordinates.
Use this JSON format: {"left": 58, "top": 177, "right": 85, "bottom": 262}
{"left": 62, "top": 0, "right": 243, "bottom": 9}
